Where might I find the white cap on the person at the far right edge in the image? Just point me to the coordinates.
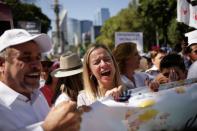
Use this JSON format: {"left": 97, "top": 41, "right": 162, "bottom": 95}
{"left": 185, "top": 30, "right": 197, "bottom": 46}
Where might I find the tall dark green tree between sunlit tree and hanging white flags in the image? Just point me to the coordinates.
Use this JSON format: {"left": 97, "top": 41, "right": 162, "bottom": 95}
{"left": 138, "top": 0, "right": 177, "bottom": 46}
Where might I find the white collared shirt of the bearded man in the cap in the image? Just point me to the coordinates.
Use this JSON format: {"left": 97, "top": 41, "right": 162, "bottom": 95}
{"left": 0, "top": 82, "right": 49, "bottom": 131}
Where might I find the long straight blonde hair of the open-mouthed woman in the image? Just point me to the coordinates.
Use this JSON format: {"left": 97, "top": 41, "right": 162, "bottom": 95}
{"left": 83, "top": 43, "right": 121, "bottom": 100}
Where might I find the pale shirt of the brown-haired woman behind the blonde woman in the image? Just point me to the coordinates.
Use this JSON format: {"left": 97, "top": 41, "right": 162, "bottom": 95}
{"left": 121, "top": 72, "right": 151, "bottom": 89}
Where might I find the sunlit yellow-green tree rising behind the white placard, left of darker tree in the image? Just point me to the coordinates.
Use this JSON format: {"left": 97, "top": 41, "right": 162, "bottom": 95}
{"left": 96, "top": 5, "right": 142, "bottom": 48}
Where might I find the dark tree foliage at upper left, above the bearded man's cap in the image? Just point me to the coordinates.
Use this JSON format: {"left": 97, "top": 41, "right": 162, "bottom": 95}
{"left": 5, "top": 0, "right": 51, "bottom": 33}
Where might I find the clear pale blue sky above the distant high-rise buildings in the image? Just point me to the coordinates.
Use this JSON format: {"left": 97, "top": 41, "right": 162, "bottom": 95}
{"left": 36, "top": 0, "right": 131, "bottom": 30}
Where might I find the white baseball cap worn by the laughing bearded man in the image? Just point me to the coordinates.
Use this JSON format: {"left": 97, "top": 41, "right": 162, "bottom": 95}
{"left": 0, "top": 29, "right": 52, "bottom": 53}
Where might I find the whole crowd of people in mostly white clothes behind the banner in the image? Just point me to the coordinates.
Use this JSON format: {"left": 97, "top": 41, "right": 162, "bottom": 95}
{"left": 0, "top": 29, "right": 197, "bottom": 131}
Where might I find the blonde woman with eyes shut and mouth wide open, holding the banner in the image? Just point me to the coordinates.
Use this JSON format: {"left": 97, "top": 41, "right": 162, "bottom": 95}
{"left": 77, "top": 44, "right": 122, "bottom": 106}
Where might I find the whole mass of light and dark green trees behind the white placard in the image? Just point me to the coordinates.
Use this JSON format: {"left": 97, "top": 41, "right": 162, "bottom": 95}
{"left": 96, "top": 0, "right": 192, "bottom": 51}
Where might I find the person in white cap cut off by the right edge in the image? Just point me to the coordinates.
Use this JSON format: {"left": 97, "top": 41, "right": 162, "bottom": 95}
{"left": 185, "top": 30, "right": 197, "bottom": 63}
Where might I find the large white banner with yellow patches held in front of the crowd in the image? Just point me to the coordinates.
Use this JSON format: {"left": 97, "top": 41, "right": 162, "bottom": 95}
{"left": 81, "top": 81, "right": 197, "bottom": 131}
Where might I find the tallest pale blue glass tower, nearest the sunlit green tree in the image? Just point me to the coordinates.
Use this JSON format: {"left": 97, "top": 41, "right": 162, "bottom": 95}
{"left": 94, "top": 8, "right": 110, "bottom": 25}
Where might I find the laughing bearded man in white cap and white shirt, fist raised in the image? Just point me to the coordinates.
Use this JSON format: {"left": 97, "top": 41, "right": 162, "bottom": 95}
{"left": 0, "top": 29, "right": 86, "bottom": 131}
